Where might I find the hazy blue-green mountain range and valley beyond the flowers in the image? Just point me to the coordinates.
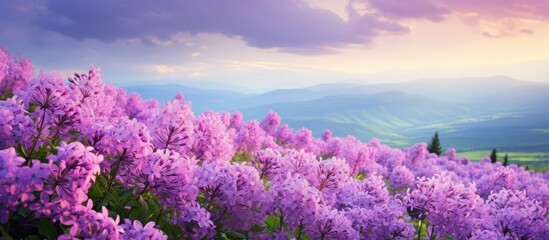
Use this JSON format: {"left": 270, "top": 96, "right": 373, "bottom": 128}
{"left": 123, "top": 76, "right": 549, "bottom": 160}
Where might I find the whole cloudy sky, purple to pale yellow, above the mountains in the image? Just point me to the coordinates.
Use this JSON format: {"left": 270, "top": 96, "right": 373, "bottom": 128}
{"left": 0, "top": 0, "right": 549, "bottom": 91}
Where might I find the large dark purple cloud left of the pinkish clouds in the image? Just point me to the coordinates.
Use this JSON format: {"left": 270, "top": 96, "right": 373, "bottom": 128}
{"left": 32, "top": 0, "right": 408, "bottom": 54}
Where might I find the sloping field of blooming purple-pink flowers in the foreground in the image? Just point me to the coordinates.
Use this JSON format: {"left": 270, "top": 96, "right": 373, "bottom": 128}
{"left": 0, "top": 48, "right": 549, "bottom": 240}
